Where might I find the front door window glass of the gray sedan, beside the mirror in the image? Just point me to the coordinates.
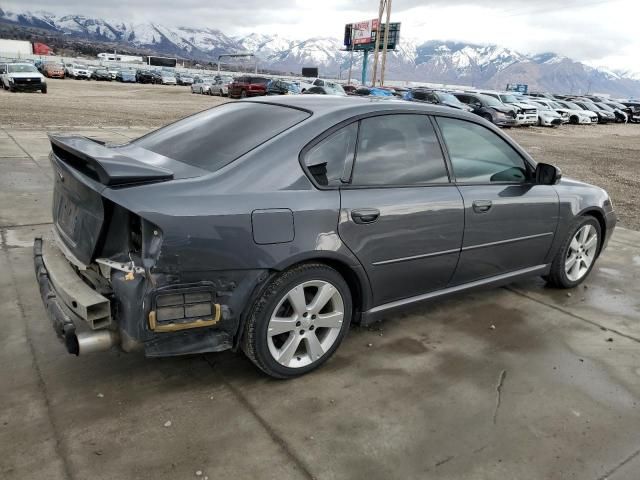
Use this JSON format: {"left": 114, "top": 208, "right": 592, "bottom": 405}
{"left": 438, "top": 117, "right": 528, "bottom": 183}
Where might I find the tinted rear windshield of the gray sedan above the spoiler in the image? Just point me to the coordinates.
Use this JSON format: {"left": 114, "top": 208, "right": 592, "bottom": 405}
{"left": 134, "top": 102, "right": 310, "bottom": 172}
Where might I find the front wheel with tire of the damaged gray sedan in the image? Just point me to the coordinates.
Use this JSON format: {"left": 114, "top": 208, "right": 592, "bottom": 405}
{"left": 547, "top": 216, "right": 602, "bottom": 288}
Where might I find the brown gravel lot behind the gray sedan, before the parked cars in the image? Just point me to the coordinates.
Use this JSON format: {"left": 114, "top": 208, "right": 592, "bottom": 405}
{"left": 0, "top": 80, "right": 640, "bottom": 229}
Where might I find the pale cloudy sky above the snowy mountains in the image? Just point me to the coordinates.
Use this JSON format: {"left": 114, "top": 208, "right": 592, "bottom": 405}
{"left": 5, "top": 0, "right": 640, "bottom": 73}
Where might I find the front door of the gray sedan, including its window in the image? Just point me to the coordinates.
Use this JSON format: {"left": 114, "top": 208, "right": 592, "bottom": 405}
{"left": 437, "top": 117, "right": 559, "bottom": 285}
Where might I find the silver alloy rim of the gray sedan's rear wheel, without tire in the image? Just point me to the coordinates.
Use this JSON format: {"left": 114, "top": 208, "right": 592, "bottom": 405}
{"left": 267, "top": 280, "right": 345, "bottom": 368}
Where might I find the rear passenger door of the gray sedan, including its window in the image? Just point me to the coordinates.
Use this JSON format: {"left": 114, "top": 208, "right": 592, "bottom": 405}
{"left": 338, "top": 114, "right": 464, "bottom": 305}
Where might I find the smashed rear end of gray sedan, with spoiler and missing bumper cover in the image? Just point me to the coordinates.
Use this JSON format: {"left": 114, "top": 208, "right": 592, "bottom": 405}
{"left": 34, "top": 136, "right": 231, "bottom": 356}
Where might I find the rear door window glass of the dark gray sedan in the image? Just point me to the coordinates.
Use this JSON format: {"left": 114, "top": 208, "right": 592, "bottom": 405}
{"left": 353, "top": 114, "right": 449, "bottom": 186}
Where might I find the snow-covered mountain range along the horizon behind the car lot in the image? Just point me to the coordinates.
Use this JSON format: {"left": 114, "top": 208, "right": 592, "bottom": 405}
{"left": 0, "top": 8, "right": 640, "bottom": 96}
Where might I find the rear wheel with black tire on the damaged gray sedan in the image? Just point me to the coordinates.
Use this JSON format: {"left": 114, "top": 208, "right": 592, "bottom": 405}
{"left": 242, "top": 263, "right": 353, "bottom": 379}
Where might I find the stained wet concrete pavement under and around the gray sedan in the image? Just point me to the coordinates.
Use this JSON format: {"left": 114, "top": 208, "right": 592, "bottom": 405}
{"left": 0, "top": 127, "right": 640, "bottom": 480}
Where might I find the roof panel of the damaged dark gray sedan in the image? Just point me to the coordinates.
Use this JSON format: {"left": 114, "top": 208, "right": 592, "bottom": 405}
{"left": 241, "top": 95, "right": 474, "bottom": 118}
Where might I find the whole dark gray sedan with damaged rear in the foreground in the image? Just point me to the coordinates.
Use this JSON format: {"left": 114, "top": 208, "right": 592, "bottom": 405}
{"left": 34, "top": 95, "right": 616, "bottom": 378}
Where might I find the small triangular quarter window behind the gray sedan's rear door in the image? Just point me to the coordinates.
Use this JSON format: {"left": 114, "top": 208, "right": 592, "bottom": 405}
{"left": 304, "top": 122, "right": 358, "bottom": 187}
